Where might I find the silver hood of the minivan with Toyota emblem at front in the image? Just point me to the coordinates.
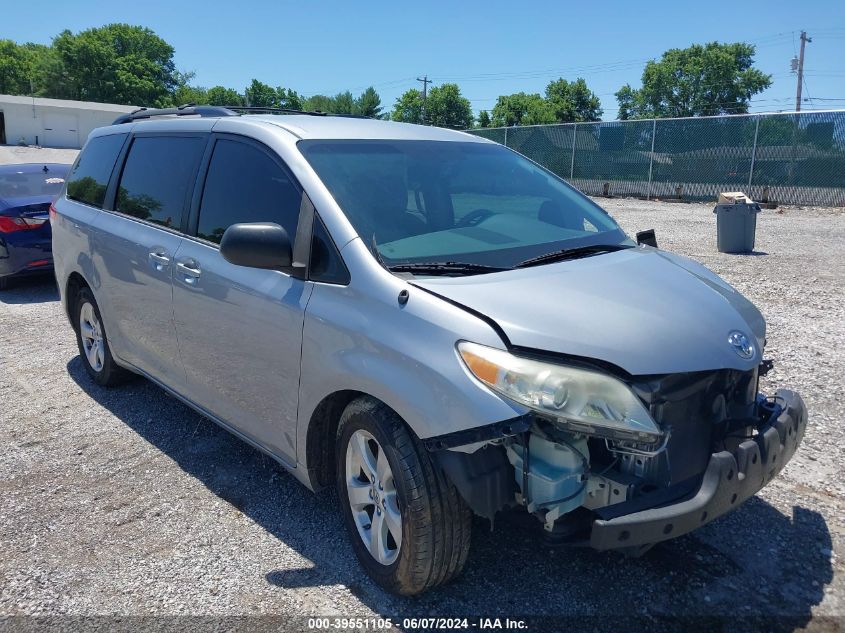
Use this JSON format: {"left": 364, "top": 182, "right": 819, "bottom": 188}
{"left": 413, "top": 247, "right": 766, "bottom": 375}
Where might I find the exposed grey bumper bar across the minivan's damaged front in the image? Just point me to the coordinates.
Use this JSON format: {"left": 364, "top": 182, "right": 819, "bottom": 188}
{"left": 589, "top": 390, "right": 807, "bottom": 550}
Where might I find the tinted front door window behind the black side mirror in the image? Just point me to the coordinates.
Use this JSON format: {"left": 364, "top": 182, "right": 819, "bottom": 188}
{"left": 197, "top": 139, "right": 302, "bottom": 243}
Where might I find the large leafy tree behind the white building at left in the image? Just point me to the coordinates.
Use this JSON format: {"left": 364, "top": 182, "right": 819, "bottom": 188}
{"left": 39, "top": 24, "right": 179, "bottom": 106}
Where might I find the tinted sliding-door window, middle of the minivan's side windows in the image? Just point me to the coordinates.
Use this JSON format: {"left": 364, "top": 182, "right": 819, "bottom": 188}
{"left": 115, "top": 136, "right": 206, "bottom": 229}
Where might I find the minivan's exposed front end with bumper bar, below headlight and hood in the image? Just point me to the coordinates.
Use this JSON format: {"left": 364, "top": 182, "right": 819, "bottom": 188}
{"left": 426, "top": 364, "right": 808, "bottom": 552}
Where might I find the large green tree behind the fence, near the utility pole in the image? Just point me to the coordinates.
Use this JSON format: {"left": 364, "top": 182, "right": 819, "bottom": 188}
{"left": 616, "top": 42, "right": 772, "bottom": 119}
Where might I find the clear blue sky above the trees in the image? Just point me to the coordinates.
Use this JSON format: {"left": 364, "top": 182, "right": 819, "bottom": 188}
{"left": 0, "top": 0, "right": 845, "bottom": 119}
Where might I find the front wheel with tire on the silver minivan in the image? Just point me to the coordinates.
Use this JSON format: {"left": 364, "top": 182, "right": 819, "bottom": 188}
{"left": 336, "top": 397, "right": 472, "bottom": 595}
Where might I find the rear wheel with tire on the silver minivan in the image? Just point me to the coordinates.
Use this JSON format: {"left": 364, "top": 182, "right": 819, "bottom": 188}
{"left": 73, "top": 288, "right": 132, "bottom": 387}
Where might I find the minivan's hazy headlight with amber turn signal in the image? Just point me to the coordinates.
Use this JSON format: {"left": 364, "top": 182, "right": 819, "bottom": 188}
{"left": 458, "top": 341, "right": 662, "bottom": 443}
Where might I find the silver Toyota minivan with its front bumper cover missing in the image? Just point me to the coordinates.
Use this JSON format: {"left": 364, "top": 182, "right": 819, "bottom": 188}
{"left": 51, "top": 106, "right": 807, "bottom": 594}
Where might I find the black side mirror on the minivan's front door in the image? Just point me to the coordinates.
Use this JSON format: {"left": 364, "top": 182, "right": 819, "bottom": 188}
{"left": 220, "top": 222, "right": 293, "bottom": 270}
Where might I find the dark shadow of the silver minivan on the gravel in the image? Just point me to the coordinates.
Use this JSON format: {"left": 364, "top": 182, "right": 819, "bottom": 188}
{"left": 67, "top": 357, "right": 833, "bottom": 630}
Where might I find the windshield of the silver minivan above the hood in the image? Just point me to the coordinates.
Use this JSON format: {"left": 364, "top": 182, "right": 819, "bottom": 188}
{"left": 299, "top": 140, "right": 630, "bottom": 268}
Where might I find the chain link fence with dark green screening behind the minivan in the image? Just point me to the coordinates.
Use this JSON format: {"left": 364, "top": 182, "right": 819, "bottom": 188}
{"left": 467, "top": 110, "right": 845, "bottom": 206}
